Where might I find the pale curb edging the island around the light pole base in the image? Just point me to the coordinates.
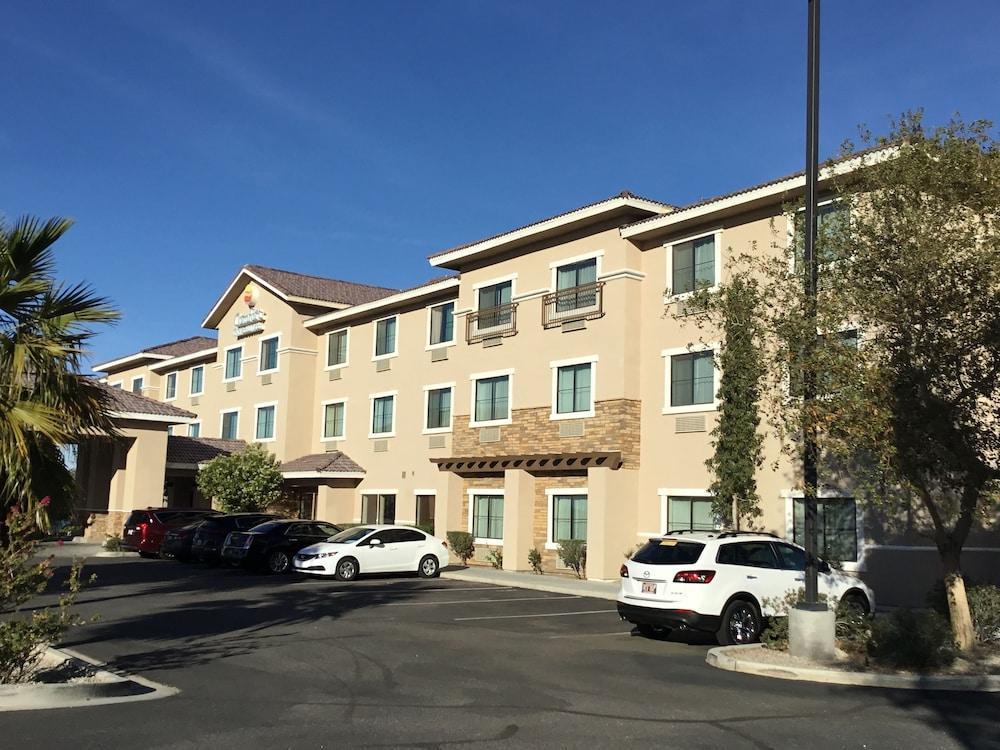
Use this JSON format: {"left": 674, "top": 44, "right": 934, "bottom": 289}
{"left": 705, "top": 643, "right": 1000, "bottom": 693}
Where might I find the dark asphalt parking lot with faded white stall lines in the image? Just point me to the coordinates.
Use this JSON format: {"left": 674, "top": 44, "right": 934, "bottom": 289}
{"left": 3, "top": 559, "right": 1000, "bottom": 748}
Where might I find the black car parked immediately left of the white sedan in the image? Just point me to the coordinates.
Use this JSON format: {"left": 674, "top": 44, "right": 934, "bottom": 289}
{"left": 222, "top": 520, "right": 341, "bottom": 573}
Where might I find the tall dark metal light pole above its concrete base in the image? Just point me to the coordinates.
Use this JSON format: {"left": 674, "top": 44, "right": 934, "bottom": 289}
{"left": 802, "top": 0, "right": 820, "bottom": 605}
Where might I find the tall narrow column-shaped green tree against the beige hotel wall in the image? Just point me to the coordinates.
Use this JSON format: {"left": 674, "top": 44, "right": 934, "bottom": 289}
{"left": 692, "top": 270, "right": 764, "bottom": 529}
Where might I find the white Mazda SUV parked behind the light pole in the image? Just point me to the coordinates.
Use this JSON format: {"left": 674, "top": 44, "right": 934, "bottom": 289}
{"left": 618, "top": 531, "right": 875, "bottom": 645}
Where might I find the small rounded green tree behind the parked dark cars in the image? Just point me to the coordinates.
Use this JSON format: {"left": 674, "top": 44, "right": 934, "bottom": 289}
{"left": 198, "top": 443, "right": 282, "bottom": 513}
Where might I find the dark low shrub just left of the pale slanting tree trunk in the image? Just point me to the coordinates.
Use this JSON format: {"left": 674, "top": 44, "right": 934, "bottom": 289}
{"left": 868, "top": 609, "right": 955, "bottom": 670}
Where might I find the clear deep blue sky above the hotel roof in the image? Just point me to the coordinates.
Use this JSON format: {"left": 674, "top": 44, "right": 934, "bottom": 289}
{"left": 0, "top": 0, "right": 1000, "bottom": 361}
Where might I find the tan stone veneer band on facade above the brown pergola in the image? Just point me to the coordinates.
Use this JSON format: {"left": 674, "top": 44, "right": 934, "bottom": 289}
{"left": 452, "top": 399, "right": 641, "bottom": 470}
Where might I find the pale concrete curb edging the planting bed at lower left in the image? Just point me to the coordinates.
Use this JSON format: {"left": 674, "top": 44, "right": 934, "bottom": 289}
{"left": 0, "top": 648, "right": 180, "bottom": 712}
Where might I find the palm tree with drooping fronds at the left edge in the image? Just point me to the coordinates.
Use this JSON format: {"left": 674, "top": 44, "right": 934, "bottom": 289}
{"left": 0, "top": 216, "right": 119, "bottom": 524}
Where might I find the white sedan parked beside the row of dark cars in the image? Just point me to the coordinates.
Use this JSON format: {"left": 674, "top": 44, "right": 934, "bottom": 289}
{"left": 292, "top": 524, "right": 448, "bottom": 581}
